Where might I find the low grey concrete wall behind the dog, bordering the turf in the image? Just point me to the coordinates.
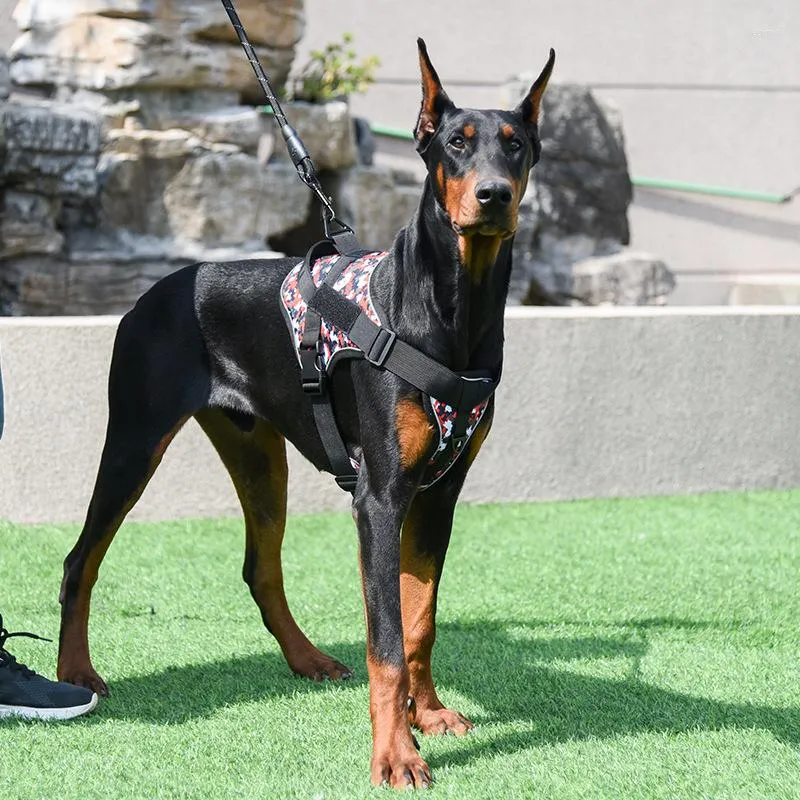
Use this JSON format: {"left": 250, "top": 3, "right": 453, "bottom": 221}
{"left": 0, "top": 307, "right": 800, "bottom": 522}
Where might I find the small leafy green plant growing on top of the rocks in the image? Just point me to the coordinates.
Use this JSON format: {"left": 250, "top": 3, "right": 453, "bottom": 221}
{"left": 291, "top": 33, "right": 381, "bottom": 103}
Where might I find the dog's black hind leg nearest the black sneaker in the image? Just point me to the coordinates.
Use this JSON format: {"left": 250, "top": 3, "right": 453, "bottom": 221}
{"left": 58, "top": 309, "right": 209, "bottom": 695}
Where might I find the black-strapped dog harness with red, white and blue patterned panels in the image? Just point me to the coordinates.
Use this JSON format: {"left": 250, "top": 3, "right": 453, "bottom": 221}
{"left": 280, "top": 242, "right": 497, "bottom": 492}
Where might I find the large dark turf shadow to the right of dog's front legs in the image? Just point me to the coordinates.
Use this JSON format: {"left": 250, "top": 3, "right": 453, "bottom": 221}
{"left": 422, "top": 618, "right": 800, "bottom": 768}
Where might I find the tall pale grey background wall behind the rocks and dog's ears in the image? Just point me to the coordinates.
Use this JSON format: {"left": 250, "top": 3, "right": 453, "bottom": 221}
{"left": 298, "top": 0, "right": 800, "bottom": 304}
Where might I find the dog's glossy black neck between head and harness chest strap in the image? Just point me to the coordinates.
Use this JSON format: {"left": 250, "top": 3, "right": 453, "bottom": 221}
{"left": 384, "top": 179, "right": 512, "bottom": 371}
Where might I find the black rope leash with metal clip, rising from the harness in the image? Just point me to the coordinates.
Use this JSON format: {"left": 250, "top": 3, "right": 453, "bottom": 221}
{"left": 222, "top": 0, "right": 355, "bottom": 239}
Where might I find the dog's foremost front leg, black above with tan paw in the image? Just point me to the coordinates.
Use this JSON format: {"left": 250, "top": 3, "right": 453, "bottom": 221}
{"left": 353, "top": 465, "right": 431, "bottom": 789}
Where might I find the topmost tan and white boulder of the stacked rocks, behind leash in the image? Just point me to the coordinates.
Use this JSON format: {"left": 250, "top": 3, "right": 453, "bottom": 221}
{"left": 10, "top": 0, "right": 304, "bottom": 107}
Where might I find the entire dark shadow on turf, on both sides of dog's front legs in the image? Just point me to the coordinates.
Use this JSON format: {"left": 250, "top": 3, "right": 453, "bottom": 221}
{"left": 43, "top": 618, "right": 800, "bottom": 768}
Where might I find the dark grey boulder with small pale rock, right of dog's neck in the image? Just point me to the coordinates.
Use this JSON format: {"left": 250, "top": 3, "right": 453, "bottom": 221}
{"left": 507, "top": 80, "right": 675, "bottom": 305}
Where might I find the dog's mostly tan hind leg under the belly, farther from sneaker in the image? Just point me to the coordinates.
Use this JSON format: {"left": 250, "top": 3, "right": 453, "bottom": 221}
{"left": 197, "top": 409, "right": 351, "bottom": 680}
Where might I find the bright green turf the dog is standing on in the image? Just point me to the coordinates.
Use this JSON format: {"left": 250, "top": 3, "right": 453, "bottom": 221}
{"left": 0, "top": 493, "right": 800, "bottom": 800}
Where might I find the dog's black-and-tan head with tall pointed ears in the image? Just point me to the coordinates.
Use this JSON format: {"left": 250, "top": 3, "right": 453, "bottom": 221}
{"left": 414, "top": 39, "right": 555, "bottom": 240}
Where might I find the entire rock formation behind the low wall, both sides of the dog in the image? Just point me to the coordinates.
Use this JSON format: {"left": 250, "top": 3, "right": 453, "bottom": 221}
{"left": 0, "top": 5, "right": 674, "bottom": 314}
